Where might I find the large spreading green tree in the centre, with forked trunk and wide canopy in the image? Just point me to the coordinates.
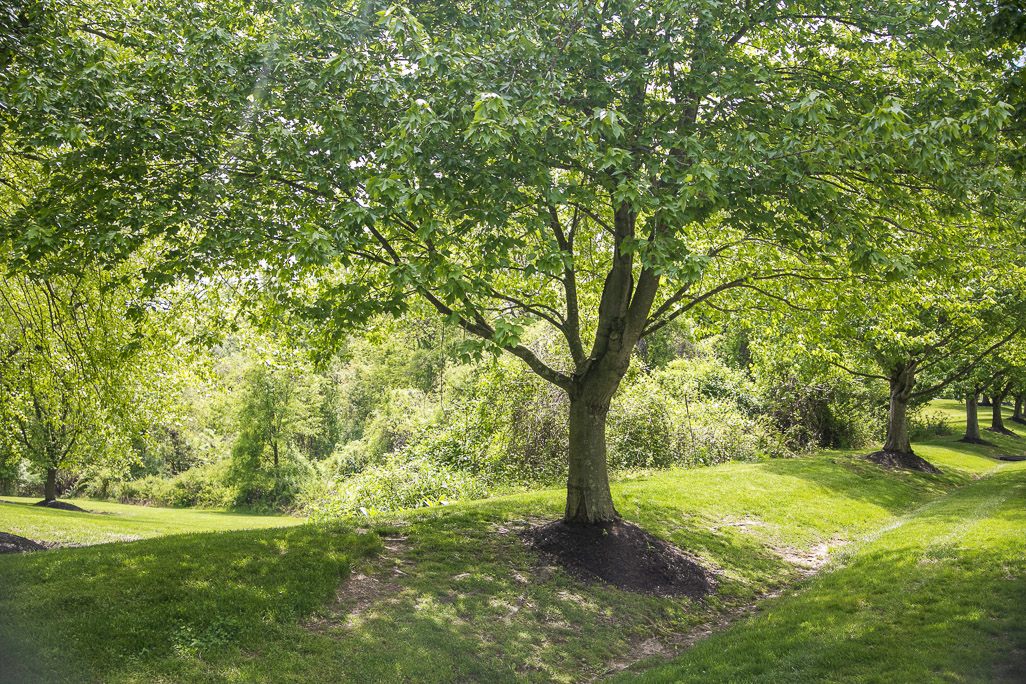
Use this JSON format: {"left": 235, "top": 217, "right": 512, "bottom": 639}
{"left": 0, "top": 0, "right": 1016, "bottom": 523}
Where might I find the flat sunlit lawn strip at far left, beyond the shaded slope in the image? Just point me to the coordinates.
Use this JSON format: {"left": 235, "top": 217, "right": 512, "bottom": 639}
{"left": 0, "top": 496, "right": 303, "bottom": 544}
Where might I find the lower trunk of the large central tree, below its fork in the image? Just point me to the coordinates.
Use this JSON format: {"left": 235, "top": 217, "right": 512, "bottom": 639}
{"left": 563, "top": 383, "right": 620, "bottom": 524}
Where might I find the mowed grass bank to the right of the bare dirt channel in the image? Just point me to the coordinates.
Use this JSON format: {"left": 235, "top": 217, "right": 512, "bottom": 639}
{"left": 631, "top": 464, "right": 1026, "bottom": 683}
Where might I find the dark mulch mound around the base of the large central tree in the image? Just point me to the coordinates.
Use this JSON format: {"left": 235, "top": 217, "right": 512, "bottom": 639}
{"left": 523, "top": 520, "right": 713, "bottom": 598}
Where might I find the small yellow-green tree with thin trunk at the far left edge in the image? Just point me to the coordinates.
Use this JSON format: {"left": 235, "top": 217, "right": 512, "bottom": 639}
{"left": 0, "top": 274, "right": 176, "bottom": 500}
